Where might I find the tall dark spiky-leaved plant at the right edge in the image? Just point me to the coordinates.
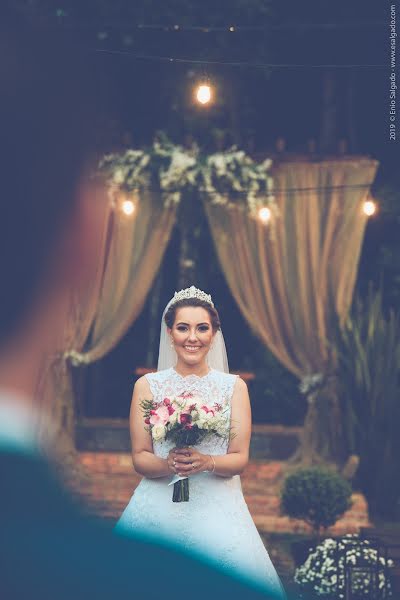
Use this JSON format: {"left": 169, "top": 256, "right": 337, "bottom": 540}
{"left": 336, "top": 288, "right": 400, "bottom": 519}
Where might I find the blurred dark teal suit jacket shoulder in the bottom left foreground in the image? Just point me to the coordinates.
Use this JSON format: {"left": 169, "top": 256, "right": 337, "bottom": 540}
{"left": 0, "top": 449, "right": 282, "bottom": 600}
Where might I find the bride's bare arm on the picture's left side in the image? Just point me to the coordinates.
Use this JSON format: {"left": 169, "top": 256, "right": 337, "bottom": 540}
{"left": 129, "top": 377, "right": 172, "bottom": 478}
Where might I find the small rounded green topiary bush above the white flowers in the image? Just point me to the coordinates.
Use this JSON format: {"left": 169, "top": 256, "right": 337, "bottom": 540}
{"left": 281, "top": 467, "right": 352, "bottom": 534}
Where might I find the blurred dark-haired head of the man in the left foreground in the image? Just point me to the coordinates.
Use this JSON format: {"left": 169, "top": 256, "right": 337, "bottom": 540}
{"left": 0, "top": 11, "right": 106, "bottom": 390}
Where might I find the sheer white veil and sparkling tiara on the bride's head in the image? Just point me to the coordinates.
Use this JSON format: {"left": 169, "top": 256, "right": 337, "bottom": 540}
{"left": 157, "top": 286, "right": 229, "bottom": 373}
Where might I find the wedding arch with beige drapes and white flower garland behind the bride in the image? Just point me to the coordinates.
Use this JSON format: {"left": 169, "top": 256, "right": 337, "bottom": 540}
{"left": 38, "top": 140, "right": 378, "bottom": 462}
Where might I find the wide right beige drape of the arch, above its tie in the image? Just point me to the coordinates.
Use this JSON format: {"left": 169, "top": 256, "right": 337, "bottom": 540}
{"left": 205, "top": 158, "right": 377, "bottom": 377}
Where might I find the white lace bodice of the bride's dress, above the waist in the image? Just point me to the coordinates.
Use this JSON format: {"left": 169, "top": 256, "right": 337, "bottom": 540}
{"left": 146, "top": 367, "right": 238, "bottom": 458}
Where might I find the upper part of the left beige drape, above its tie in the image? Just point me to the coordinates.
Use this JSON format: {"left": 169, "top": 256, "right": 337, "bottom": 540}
{"left": 69, "top": 192, "right": 176, "bottom": 363}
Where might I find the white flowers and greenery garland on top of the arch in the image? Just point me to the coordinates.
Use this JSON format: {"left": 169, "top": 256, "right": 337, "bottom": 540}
{"left": 99, "top": 134, "right": 277, "bottom": 215}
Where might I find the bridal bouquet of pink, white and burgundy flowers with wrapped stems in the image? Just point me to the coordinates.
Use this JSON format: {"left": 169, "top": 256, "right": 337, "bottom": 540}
{"left": 141, "top": 393, "right": 230, "bottom": 502}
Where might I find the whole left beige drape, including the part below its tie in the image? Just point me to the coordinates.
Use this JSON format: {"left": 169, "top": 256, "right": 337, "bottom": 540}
{"left": 37, "top": 192, "right": 176, "bottom": 442}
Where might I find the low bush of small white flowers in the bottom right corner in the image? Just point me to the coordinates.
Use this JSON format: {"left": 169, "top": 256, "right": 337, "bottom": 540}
{"left": 294, "top": 534, "right": 393, "bottom": 600}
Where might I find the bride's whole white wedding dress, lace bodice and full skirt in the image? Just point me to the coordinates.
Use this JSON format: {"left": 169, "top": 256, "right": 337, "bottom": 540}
{"left": 116, "top": 368, "right": 286, "bottom": 598}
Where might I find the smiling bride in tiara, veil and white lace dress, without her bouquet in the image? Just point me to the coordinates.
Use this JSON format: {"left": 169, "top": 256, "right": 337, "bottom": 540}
{"left": 116, "top": 286, "right": 286, "bottom": 598}
